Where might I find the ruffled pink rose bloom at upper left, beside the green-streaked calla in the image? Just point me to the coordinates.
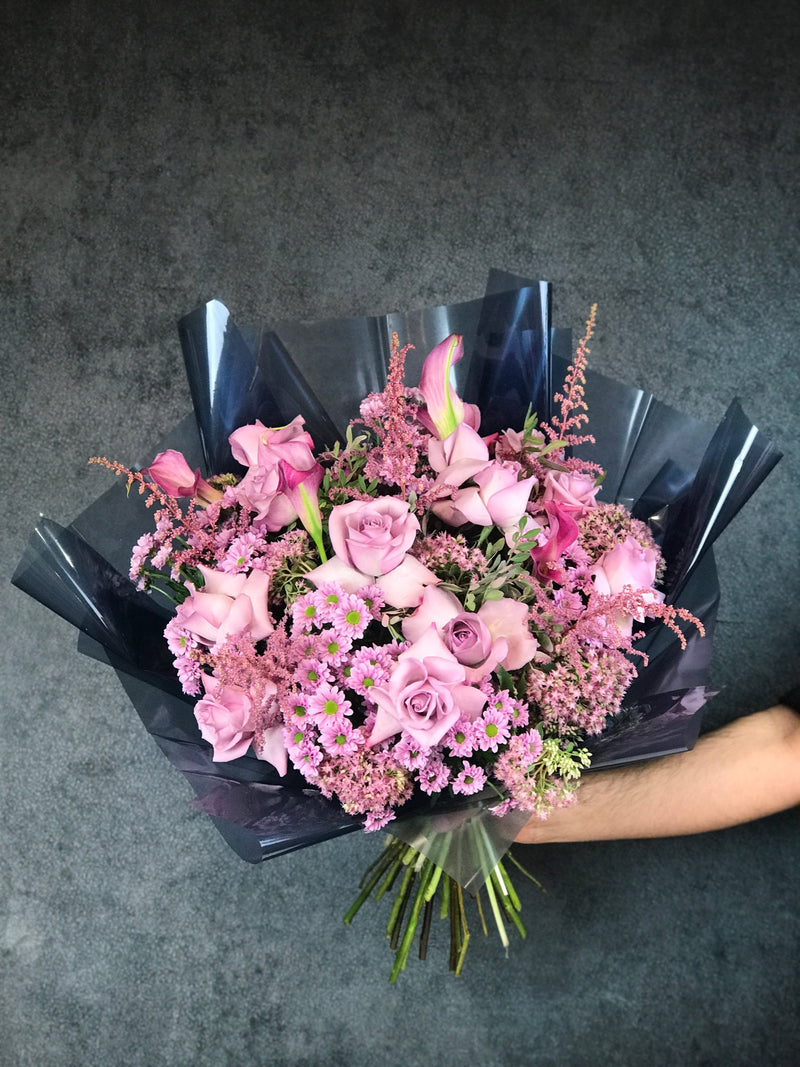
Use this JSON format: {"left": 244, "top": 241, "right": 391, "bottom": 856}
{"left": 228, "top": 415, "right": 322, "bottom": 532}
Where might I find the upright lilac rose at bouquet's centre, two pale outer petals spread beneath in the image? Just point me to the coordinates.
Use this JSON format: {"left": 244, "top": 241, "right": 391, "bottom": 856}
{"left": 307, "top": 496, "right": 438, "bottom": 607}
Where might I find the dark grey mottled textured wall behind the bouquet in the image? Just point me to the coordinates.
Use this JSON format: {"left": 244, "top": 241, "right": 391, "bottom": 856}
{"left": 0, "top": 0, "right": 800, "bottom": 1067}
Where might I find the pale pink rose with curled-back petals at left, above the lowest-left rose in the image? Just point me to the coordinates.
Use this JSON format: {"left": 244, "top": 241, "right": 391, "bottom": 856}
{"left": 176, "top": 566, "right": 273, "bottom": 647}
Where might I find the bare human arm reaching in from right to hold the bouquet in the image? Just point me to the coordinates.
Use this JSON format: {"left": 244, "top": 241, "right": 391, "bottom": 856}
{"left": 516, "top": 704, "right": 800, "bottom": 844}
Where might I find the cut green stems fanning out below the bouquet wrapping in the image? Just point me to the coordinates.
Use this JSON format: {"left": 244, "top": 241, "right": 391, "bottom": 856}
{"left": 345, "top": 833, "right": 535, "bottom": 984}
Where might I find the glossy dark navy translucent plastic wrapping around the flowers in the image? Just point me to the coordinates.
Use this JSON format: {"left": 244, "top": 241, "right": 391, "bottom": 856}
{"left": 13, "top": 271, "right": 780, "bottom": 866}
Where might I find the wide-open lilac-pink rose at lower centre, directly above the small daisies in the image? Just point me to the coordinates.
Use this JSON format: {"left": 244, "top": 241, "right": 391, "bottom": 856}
{"left": 369, "top": 626, "right": 487, "bottom": 749}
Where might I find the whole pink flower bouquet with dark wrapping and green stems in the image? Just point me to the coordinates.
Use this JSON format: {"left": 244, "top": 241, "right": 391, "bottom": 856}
{"left": 9, "top": 271, "right": 777, "bottom": 981}
